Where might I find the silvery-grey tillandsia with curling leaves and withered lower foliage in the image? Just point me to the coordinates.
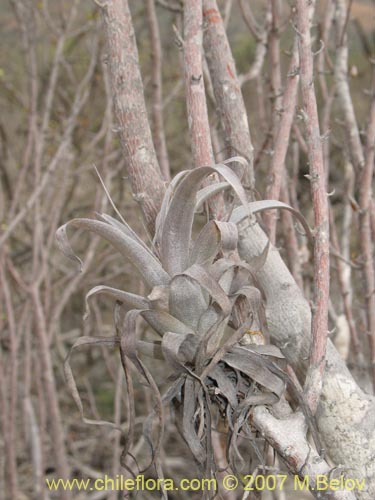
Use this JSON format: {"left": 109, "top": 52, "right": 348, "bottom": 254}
{"left": 56, "top": 158, "right": 309, "bottom": 488}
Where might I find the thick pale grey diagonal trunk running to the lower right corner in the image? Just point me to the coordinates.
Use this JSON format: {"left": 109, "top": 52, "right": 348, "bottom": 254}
{"left": 239, "top": 223, "right": 375, "bottom": 500}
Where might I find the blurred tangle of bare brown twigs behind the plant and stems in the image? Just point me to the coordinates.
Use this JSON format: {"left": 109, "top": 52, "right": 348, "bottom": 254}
{"left": 0, "top": 0, "right": 375, "bottom": 500}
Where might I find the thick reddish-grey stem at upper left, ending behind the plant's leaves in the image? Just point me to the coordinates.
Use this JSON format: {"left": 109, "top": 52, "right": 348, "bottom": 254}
{"left": 98, "top": 0, "right": 164, "bottom": 234}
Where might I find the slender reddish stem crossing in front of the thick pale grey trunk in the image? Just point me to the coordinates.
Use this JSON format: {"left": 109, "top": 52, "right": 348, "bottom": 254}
{"left": 297, "top": 0, "right": 329, "bottom": 412}
